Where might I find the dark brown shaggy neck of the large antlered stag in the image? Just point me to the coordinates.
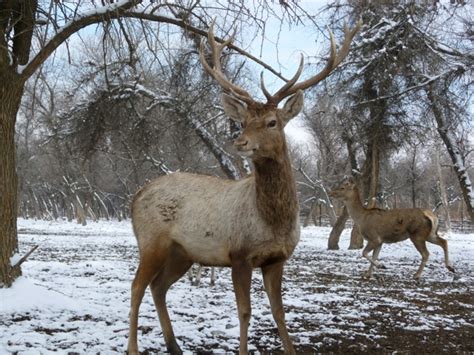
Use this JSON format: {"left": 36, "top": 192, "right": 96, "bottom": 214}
{"left": 253, "top": 146, "right": 299, "bottom": 233}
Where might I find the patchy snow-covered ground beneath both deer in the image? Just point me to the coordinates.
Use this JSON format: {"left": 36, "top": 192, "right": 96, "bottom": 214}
{"left": 0, "top": 220, "right": 474, "bottom": 354}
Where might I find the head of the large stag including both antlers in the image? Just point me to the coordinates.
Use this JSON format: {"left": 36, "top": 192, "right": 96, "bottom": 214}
{"left": 200, "top": 22, "right": 360, "bottom": 161}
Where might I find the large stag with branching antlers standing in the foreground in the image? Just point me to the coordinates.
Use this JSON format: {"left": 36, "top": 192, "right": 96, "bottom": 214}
{"left": 128, "top": 23, "right": 360, "bottom": 354}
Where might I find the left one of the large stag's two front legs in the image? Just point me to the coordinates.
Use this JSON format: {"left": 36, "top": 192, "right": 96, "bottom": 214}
{"left": 231, "top": 260, "right": 252, "bottom": 355}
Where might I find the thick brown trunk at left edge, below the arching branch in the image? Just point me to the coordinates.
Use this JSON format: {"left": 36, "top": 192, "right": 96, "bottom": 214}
{"left": 0, "top": 69, "right": 23, "bottom": 287}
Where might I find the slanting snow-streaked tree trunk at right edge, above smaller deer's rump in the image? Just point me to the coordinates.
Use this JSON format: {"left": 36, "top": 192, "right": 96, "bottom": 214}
{"left": 426, "top": 85, "right": 474, "bottom": 223}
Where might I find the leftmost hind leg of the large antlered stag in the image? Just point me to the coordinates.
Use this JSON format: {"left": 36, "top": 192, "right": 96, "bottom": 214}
{"left": 128, "top": 252, "right": 166, "bottom": 354}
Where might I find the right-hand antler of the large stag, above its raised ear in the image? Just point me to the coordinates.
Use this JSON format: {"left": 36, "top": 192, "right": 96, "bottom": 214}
{"left": 260, "top": 21, "right": 362, "bottom": 105}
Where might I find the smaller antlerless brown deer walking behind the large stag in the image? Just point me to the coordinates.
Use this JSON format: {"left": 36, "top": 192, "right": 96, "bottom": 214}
{"left": 330, "top": 178, "right": 454, "bottom": 280}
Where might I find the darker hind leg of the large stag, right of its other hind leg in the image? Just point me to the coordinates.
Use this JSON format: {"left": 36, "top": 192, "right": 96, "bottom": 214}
{"left": 150, "top": 244, "right": 192, "bottom": 354}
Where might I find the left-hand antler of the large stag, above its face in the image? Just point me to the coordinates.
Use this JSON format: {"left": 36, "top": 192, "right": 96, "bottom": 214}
{"left": 199, "top": 20, "right": 257, "bottom": 105}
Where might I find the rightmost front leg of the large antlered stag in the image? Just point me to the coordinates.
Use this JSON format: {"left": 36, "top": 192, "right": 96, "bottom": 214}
{"left": 262, "top": 262, "right": 296, "bottom": 354}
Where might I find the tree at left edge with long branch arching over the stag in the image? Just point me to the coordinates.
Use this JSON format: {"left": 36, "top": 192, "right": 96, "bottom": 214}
{"left": 0, "top": 0, "right": 304, "bottom": 287}
